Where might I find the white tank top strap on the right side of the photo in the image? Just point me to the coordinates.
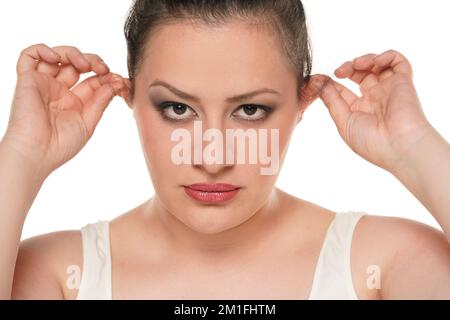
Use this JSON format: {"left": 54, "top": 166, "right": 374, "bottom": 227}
{"left": 309, "top": 211, "right": 366, "bottom": 300}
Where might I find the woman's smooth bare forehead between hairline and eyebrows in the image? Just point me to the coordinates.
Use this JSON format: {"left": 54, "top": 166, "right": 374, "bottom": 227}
{"left": 140, "top": 22, "right": 295, "bottom": 90}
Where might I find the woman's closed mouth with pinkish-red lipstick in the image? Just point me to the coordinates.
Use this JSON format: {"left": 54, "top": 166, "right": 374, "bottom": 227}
{"left": 184, "top": 183, "right": 241, "bottom": 203}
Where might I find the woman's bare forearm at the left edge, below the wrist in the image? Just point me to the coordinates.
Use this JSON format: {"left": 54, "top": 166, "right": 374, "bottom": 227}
{"left": 0, "top": 142, "right": 44, "bottom": 299}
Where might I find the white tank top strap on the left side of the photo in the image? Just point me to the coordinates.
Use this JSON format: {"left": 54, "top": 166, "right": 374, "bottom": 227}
{"left": 77, "top": 221, "right": 112, "bottom": 300}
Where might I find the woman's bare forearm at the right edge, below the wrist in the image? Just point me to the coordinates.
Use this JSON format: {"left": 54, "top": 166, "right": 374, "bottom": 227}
{"left": 391, "top": 127, "right": 450, "bottom": 242}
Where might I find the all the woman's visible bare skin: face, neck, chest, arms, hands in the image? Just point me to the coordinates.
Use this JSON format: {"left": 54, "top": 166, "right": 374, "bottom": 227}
{"left": 0, "top": 22, "right": 450, "bottom": 299}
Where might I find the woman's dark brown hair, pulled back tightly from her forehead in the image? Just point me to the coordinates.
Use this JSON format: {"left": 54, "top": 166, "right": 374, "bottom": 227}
{"left": 124, "top": 0, "right": 312, "bottom": 100}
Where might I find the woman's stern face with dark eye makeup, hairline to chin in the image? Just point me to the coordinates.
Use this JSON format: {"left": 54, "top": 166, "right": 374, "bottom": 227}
{"left": 132, "top": 22, "right": 302, "bottom": 234}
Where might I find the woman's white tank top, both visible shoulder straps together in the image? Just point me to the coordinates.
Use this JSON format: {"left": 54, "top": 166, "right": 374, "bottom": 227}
{"left": 77, "top": 211, "right": 366, "bottom": 300}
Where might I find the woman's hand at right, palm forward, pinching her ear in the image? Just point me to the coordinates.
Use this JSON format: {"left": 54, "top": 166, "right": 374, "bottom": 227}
{"left": 320, "top": 50, "right": 433, "bottom": 172}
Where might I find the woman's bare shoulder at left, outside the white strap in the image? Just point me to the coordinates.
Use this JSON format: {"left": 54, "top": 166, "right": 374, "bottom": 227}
{"left": 12, "top": 230, "right": 83, "bottom": 299}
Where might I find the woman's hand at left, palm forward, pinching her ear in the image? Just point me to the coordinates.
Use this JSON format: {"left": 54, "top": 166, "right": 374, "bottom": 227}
{"left": 1, "top": 44, "right": 130, "bottom": 179}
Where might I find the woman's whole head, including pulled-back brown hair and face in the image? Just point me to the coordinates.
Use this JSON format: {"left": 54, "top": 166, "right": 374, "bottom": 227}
{"left": 125, "top": 0, "right": 320, "bottom": 233}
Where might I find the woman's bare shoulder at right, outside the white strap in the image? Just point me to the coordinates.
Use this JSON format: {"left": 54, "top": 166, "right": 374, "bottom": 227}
{"left": 352, "top": 215, "right": 450, "bottom": 299}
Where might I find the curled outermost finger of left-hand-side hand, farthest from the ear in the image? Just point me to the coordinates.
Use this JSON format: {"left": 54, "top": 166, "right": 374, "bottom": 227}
{"left": 16, "top": 43, "right": 61, "bottom": 74}
